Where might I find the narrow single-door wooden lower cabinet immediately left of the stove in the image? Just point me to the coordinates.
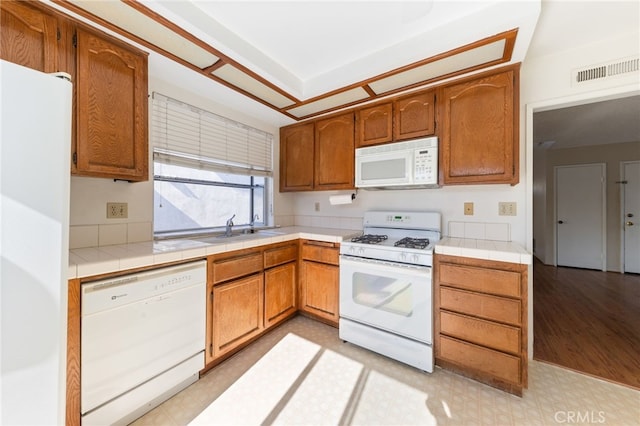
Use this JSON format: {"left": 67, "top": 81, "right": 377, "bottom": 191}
{"left": 300, "top": 241, "right": 340, "bottom": 326}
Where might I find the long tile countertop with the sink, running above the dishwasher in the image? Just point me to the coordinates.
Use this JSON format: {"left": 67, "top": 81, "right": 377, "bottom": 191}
{"left": 68, "top": 226, "right": 362, "bottom": 279}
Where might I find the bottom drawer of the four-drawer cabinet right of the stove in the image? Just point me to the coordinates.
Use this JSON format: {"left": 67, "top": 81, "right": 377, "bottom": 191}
{"left": 436, "top": 336, "right": 522, "bottom": 384}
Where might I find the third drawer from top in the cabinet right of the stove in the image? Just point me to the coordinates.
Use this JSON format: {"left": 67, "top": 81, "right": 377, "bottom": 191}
{"left": 440, "top": 311, "right": 521, "bottom": 354}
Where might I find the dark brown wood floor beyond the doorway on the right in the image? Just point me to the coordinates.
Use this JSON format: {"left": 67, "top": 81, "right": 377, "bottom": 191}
{"left": 533, "top": 258, "right": 640, "bottom": 389}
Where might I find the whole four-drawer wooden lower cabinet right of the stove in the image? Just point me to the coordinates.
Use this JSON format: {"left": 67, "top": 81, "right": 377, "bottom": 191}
{"left": 433, "top": 254, "right": 528, "bottom": 396}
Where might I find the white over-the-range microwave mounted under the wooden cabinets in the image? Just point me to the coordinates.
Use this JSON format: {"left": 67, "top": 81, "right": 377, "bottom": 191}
{"left": 356, "top": 136, "right": 438, "bottom": 189}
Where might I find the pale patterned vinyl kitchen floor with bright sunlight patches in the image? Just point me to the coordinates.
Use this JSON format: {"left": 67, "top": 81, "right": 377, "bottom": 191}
{"left": 134, "top": 316, "right": 640, "bottom": 426}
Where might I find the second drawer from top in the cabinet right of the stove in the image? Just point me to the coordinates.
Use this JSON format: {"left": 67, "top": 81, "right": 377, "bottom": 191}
{"left": 440, "top": 287, "right": 521, "bottom": 325}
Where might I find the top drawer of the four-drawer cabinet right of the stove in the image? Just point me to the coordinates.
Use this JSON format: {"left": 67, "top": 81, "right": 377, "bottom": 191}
{"left": 438, "top": 263, "right": 520, "bottom": 297}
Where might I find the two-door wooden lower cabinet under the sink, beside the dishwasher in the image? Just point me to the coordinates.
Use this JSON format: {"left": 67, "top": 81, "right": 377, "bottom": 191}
{"left": 205, "top": 240, "right": 298, "bottom": 369}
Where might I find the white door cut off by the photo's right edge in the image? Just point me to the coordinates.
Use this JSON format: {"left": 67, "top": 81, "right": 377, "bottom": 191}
{"left": 622, "top": 161, "right": 640, "bottom": 274}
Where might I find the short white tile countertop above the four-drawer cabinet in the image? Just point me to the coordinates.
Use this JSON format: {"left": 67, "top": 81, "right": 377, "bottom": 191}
{"left": 435, "top": 237, "right": 533, "bottom": 265}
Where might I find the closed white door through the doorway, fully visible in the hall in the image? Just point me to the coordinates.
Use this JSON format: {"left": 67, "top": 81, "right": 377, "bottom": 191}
{"left": 555, "top": 164, "right": 606, "bottom": 270}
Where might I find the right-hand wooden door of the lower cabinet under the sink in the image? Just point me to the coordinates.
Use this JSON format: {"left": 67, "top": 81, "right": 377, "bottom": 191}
{"left": 264, "top": 262, "right": 296, "bottom": 327}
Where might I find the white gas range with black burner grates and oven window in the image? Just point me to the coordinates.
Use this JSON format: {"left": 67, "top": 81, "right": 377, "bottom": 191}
{"left": 339, "top": 211, "right": 441, "bottom": 372}
